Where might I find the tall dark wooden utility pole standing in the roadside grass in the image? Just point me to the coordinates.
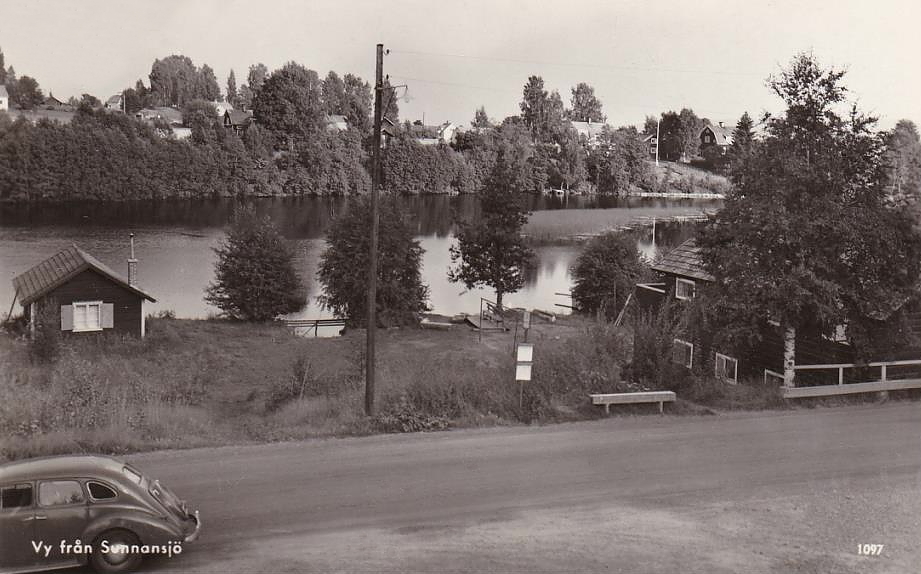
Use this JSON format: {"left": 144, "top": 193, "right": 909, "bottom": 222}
{"left": 365, "top": 44, "right": 384, "bottom": 416}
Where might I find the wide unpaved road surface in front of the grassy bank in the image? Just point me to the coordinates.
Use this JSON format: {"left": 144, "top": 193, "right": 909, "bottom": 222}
{"left": 115, "top": 402, "right": 921, "bottom": 574}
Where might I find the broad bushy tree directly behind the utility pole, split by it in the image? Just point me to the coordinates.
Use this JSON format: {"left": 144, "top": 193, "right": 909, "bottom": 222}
{"left": 318, "top": 197, "right": 428, "bottom": 326}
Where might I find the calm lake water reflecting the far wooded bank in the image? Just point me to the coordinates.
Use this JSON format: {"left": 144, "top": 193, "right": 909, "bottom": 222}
{"left": 0, "top": 196, "right": 719, "bottom": 324}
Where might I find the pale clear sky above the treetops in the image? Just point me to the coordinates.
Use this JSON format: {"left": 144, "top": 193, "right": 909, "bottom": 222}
{"left": 0, "top": 0, "right": 921, "bottom": 129}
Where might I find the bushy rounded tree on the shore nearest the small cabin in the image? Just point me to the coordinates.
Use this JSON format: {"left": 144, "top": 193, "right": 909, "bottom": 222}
{"left": 205, "top": 207, "right": 306, "bottom": 321}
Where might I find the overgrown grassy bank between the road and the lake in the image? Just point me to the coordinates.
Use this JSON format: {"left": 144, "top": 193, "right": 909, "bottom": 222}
{"left": 0, "top": 317, "right": 792, "bottom": 459}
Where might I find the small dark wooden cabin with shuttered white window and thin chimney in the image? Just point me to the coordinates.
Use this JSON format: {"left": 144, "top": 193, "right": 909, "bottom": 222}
{"left": 13, "top": 245, "right": 156, "bottom": 337}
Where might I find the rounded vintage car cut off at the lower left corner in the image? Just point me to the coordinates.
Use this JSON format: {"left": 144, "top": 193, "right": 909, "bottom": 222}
{"left": 0, "top": 456, "right": 201, "bottom": 573}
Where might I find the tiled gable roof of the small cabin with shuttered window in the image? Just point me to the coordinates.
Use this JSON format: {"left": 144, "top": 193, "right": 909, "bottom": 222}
{"left": 13, "top": 245, "right": 157, "bottom": 306}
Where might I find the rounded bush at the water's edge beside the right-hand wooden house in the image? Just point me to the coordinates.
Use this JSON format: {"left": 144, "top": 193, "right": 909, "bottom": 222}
{"left": 572, "top": 232, "right": 646, "bottom": 319}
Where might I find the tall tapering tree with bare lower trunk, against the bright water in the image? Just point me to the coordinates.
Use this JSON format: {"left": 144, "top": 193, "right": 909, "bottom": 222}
{"left": 448, "top": 154, "right": 534, "bottom": 309}
